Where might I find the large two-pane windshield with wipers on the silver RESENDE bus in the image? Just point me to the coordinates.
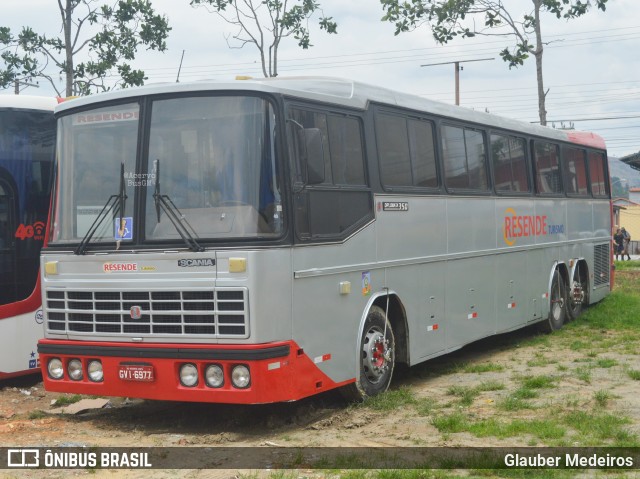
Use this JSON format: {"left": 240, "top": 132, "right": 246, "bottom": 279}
{"left": 52, "top": 95, "right": 282, "bottom": 245}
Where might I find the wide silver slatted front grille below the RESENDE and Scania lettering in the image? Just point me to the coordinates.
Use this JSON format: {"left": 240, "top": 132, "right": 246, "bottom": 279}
{"left": 44, "top": 288, "right": 249, "bottom": 338}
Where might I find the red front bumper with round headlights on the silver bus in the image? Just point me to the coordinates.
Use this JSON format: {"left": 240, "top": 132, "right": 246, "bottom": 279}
{"left": 38, "top": 339, "right": 353, "bottom": 404}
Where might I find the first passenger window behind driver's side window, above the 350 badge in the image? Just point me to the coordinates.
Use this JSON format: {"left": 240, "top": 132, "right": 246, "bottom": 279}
{"left": 376, "top": 113, "right": 438, "bottom": 188}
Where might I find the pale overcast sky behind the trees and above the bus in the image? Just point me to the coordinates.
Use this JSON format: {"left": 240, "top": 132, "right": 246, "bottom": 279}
{"left": 0, "top": 0, "right": 640, "bottom": 157}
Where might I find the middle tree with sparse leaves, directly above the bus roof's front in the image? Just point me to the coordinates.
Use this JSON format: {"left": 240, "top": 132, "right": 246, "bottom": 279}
{"left": 190, "top": 0, "right": 338, "bottom": 77}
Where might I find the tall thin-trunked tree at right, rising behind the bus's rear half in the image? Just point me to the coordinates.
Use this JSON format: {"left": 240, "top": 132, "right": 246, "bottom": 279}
{"left": 380, "top": 0, "right": 607, "bottom": 125}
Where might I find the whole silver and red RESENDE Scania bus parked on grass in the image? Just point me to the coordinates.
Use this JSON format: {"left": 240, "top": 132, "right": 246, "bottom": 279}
{"left": 38, "top": 78, "right": 612, "bottom": 403}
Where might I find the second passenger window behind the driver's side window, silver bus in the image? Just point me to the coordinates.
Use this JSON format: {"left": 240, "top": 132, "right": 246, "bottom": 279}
{"left": 442, "top": 126, "right": 488, "bottom": 191}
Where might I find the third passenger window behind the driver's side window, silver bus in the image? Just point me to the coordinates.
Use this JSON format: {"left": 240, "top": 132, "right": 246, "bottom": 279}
{"left": 491, "top": 135, "right": 530, "bottom": 192}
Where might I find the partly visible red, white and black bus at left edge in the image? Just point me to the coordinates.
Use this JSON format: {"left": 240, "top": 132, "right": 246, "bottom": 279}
{"left": 0, "top": 95, "right": 57, "bottom": 379}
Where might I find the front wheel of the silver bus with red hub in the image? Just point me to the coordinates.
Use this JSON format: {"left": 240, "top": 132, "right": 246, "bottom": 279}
{"left": 342, "top": 306, "right": 395, "bottom": 401}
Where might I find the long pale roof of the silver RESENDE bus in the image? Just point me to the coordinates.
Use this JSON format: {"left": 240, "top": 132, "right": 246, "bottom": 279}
{"left": 56, "top": 77, "right": 605, "bottom": 149}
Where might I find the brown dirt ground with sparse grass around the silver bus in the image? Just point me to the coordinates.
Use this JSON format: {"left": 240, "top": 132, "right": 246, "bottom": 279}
{"left": 0, "top": 272, "right": 640, "bottom": 479}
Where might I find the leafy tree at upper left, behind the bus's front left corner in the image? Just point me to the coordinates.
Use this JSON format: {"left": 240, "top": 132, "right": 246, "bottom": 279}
{"left": 0, "top": 0, "right": 171, "bottom": 96}
